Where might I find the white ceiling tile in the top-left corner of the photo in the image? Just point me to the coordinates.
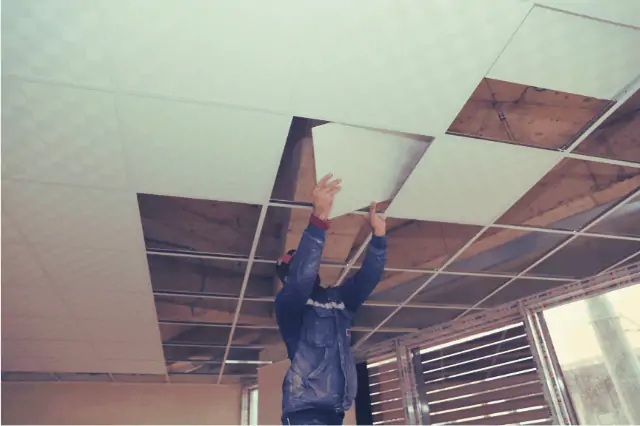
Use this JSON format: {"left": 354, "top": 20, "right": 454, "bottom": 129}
{"left": 2, "top": 0, "right": 111, "bottom": 87}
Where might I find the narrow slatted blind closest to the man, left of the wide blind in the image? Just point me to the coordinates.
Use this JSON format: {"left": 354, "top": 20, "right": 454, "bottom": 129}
{"left": 367, "top": 357, "right": 405, "bottom": 425}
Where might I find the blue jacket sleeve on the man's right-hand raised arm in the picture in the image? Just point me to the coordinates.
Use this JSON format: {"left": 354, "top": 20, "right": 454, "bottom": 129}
{"left": 339, "top": 235, "right": 387, "bottom": 312}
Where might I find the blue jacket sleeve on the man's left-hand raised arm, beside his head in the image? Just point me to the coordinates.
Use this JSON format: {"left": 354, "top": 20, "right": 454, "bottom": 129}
{"left": 275, "top": 216, "right": 327, "bottom": 315}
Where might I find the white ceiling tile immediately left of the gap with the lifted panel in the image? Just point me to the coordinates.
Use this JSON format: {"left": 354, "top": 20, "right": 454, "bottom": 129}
{"left": 119, "top": 96, "right": 291, "bottom": 203}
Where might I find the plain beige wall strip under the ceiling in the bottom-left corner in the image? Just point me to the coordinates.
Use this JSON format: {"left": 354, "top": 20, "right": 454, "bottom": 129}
{"left": 2, "top": 383, "right": 242, "bottom": 424}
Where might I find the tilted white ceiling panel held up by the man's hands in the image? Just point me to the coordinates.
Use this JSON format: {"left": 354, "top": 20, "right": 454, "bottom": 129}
{"left": 313, "top": 123, "right": 429, "bottom": 218}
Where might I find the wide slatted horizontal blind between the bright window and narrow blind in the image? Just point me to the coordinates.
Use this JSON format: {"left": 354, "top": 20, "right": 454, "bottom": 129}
{"left": 418, "top": 323, "right": 551, "bottom": 425}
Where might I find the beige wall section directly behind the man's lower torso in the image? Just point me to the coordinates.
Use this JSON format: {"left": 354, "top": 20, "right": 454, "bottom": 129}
{"left": 258, "top": 360, "right": 356, "bottom": 425}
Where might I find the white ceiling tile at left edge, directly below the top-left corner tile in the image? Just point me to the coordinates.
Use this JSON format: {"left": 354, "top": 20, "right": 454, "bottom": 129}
{"left": 2, "top": 78, "right": 127, "bottom": 188}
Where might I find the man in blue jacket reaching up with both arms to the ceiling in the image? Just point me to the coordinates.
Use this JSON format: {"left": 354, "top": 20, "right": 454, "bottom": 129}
{"left": 275, "top": 175, "right": 387, "bottom": 425}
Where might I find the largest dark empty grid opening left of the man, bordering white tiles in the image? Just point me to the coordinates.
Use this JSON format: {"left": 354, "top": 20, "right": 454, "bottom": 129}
{"left": 138, "top": 194, "right": 260, "bottom": 256}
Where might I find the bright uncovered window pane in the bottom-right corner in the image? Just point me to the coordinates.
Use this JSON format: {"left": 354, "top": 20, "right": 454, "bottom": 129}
{"left": 544, "top": 284, "right": 640, "bottom": 425}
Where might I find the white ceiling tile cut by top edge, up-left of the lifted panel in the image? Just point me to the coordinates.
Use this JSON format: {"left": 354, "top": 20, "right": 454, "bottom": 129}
{"left": 107, "top": 0, "right": 304, "bottom": 111}
